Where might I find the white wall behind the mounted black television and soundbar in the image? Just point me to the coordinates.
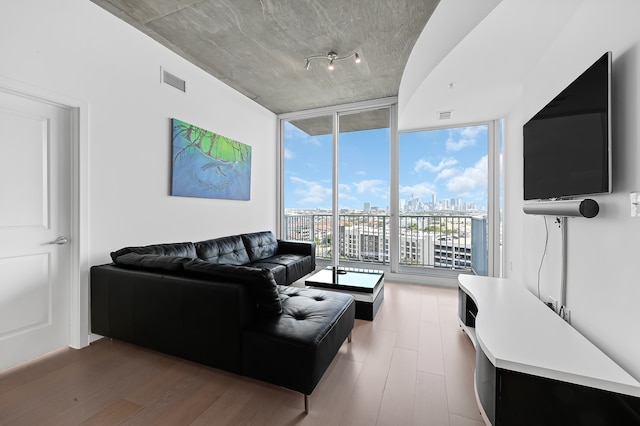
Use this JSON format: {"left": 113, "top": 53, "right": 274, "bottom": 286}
{"left": 505, "top": 0, "right": 640, "bottom": 378}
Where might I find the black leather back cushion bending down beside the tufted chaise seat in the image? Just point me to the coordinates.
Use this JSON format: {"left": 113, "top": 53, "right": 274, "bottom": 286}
{"left": 184, "top": 259, "right": 282, "bottom": 316}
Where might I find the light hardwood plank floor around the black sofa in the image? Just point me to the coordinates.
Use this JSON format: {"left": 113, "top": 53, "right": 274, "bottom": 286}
{"left": 0, "top": 282, "right": 484, "bottom": 426}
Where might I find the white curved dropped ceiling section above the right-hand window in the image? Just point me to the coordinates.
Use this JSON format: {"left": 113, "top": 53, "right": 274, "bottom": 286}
{"left": 398, "top": 0, "right": 582, "bottom": 131}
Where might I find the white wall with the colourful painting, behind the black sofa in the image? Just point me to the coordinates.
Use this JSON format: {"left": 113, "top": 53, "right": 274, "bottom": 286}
{"left": 0, "top": 0, "right": 276, "bottom": 344}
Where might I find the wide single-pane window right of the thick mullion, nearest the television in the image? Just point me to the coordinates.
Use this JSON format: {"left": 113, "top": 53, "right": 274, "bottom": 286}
{"left": 399, "top": 122, "right": 500, "bottom": 275}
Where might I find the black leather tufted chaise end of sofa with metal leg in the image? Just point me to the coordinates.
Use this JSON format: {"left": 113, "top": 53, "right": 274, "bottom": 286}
{"left": 242, "top": 286, "right": 355, "bottom": 411}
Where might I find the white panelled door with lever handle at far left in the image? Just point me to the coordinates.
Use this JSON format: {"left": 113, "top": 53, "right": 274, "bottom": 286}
{"left": 0, "top": 91, "right": 71, "bottom": 370}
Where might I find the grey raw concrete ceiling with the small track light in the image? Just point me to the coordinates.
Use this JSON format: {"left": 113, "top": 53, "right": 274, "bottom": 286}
{"left": 91, "top": 0, "right": 440, "bottom": 129}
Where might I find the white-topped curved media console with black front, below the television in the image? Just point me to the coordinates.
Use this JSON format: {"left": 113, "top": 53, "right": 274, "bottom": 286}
{"left": 458, "top": 275, "right": 640, "bottom": 426}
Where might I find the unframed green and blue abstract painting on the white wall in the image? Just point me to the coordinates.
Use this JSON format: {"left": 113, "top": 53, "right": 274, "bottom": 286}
{"left": 171, "top": 118, "right": 251, "bottom": 200}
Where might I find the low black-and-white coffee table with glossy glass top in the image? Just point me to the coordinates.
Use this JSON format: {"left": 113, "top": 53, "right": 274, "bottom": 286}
{"left": 305, "top": 266, "right": 384, "bottom": 321}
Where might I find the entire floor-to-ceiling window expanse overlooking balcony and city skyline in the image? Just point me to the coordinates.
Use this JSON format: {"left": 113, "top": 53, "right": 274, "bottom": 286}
{"left": 279, "top": 105, "right": 501, "bottom": 275}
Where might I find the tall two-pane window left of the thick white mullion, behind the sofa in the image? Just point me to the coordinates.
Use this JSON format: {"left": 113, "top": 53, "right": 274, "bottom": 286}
{"left": 280, "top": 102, "right": 391, "bottom": 265}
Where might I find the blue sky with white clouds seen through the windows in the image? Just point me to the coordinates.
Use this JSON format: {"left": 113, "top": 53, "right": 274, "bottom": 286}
{"left": 284, "top": 123, "right": 488, "bottom": 209}
